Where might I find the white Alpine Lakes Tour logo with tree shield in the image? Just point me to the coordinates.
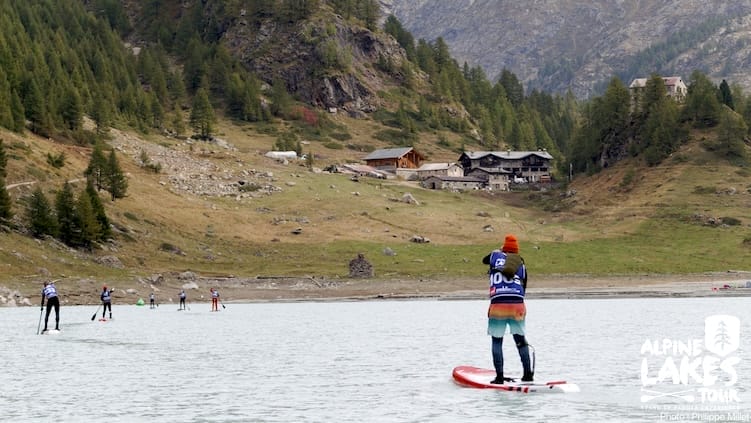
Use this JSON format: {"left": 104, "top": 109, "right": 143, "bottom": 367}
{"left": 641, "top": 315, "right": 741, "bottom": 405}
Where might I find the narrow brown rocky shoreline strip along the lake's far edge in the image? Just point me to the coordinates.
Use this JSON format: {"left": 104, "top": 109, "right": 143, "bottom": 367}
{"left": 0, "top": 271, "right": 751, "bottom": 307}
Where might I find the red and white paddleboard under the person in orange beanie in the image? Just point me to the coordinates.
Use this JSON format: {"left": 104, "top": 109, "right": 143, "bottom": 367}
{"left": 452, "top": 366, "right": 579, "bottom": 394}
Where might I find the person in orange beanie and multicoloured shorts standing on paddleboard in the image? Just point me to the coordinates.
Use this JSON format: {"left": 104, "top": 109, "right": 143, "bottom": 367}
{"left": 482, "top": 234, "right": 534, "bottom": 384}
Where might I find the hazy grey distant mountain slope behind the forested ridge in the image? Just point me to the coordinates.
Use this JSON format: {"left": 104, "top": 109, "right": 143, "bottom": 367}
{"left": 381, "top": 0, "right": 751, "bottom": 97}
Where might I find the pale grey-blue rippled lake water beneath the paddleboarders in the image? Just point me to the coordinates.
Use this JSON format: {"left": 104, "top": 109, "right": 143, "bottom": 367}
{"left": 0, "top": 298, "right": 751, "bottom": 422}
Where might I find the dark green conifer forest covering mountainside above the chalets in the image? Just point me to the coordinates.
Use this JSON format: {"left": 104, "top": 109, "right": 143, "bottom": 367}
{"left": 0, "top": 0, "right": 751, "bottom": 245}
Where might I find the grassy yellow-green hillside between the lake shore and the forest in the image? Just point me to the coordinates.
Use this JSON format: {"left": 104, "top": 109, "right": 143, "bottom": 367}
{"left": 0, "top": 118, "right": 751, "bottom": 294}
